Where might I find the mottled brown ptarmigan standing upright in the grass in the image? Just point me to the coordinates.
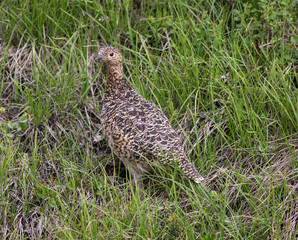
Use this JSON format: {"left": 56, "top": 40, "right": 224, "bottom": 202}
{"left": 95, "top": 46, "right": 204, "bottom": 183}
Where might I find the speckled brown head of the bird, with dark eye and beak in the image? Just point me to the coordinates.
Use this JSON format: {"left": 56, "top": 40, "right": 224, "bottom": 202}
{"left": 95, "top": 46, "right": 122, "bottom": 67}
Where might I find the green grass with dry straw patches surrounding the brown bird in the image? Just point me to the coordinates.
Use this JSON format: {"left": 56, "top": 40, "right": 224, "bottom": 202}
{"left": 0, "top": 0, "right": 298, "bottom": 240}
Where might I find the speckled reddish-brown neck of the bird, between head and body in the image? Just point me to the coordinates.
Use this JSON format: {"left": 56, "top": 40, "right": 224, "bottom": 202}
{"left": 106, "top": 65, "right": 127, "bottom": 92}
